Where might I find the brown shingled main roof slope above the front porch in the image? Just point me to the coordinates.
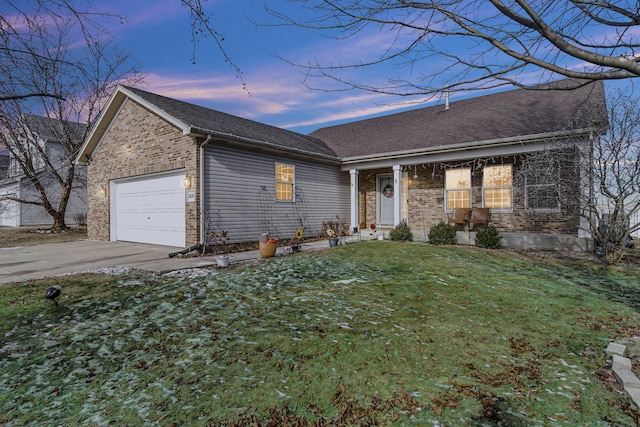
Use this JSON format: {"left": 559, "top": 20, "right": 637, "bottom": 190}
{"left": 310, "top": 80, "right": 605, "bottom": 158}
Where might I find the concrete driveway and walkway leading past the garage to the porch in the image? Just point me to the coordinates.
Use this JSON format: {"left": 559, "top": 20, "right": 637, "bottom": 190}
{"left": 0, "top": 240, "right": 329, "bottom": 283}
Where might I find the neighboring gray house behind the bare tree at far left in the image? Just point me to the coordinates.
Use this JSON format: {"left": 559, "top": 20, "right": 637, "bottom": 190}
{"left": 0, "top": 115, "right": 87, "bottom": 227}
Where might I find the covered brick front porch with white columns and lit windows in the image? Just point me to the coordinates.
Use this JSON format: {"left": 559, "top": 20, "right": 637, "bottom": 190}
{"left": 349, "top": 156, "right": 593, "bottom": 251}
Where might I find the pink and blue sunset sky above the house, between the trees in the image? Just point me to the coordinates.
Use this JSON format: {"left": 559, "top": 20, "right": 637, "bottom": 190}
{"left": 5, "top": 0, "right": 633, "bottom": 133}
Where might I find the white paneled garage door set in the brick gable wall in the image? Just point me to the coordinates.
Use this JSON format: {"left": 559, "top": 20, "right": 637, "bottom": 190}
{"left": 111, "top": 172, "right": 185, "bottom": 247}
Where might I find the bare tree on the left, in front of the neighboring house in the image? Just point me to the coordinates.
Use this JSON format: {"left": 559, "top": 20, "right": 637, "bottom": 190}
{"left": 0, "top": 0, "right": 138, "bottom": 230}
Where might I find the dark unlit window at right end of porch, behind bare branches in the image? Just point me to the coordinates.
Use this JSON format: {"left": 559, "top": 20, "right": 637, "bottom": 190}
{"left": 525, "top": 160, "right": 560, "bottom": 210}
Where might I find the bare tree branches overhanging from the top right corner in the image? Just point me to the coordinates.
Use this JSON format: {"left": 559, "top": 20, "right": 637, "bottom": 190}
{"left": 270, "top": 0, "right": 640, "bottom": 96}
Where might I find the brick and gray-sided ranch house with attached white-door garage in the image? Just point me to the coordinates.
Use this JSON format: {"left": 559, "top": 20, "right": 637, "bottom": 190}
{"left": 77, "top": 81, "right": 604, "bottom": 249}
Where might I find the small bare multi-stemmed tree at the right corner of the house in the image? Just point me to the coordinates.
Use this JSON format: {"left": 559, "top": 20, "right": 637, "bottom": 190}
{"left": 519, "top": 91, "right": 640, "bottom": 263}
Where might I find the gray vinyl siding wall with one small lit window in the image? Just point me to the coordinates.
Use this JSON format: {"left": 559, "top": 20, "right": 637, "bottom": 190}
{"left": 203, "top": 145, "right": 350, "bottom": 242}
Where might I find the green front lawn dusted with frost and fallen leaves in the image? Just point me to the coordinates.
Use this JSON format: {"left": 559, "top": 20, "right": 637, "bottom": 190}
{"left": 0, "top": 242, "right": 640, "bottom": 426}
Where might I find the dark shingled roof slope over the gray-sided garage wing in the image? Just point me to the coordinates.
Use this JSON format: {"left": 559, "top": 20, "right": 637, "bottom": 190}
{"left": 124, "top": 86, "right": 337, "bottom": 159}
